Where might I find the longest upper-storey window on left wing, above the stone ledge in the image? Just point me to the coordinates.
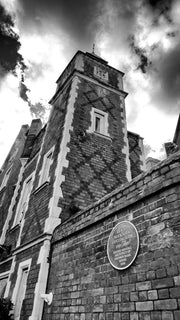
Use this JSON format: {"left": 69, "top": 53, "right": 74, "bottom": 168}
{"left": 13, "top": 176, "right": 32, "bottom": 226}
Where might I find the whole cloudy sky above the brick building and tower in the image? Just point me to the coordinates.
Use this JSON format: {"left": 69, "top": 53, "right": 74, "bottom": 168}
{"left": 0, "top": 0, "right": 180, "bottom": 165}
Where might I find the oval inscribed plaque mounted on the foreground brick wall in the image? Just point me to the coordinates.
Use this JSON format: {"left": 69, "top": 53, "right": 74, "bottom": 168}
{"left": 107, "top": 221, "right": 139, "bottom": 270}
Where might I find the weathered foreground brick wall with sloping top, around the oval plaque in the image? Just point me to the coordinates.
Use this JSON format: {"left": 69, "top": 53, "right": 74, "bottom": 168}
{"left": 43, "top": 153, "right": 180, "bottom": 320}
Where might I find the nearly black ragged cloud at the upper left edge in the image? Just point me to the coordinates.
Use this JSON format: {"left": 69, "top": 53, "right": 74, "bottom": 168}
{"left": 0, "top": 4, "right": 25, "bottom": 77}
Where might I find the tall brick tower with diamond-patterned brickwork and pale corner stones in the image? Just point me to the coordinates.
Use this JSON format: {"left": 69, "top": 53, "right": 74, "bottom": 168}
{"left": 46, "top": 51, "right": 131, "bottom": 217}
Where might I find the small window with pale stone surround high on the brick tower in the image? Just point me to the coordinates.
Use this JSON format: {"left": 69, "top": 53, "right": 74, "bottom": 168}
{"left": 88, "top": 108, "right": 109, "bottom": 136}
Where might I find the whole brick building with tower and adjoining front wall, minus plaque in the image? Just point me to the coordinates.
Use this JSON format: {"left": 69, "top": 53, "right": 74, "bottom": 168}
{"left": 0, "top": 51, "right": 180, "bottom": 320}
